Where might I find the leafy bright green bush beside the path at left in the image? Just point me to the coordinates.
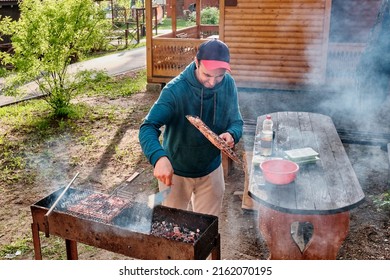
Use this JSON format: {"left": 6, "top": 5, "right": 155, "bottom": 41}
{"left": 0, "top": 0, "right": 110, "bottom": 117}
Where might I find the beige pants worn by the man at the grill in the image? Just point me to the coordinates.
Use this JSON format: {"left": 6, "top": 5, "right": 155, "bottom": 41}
{"left": 158, "top": 164, "right": 225, "bottom": 216}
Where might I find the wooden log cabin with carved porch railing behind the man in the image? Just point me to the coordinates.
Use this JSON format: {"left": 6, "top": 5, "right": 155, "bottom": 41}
{"left": 146, "top": 0, "right": 381, "bottom": 89}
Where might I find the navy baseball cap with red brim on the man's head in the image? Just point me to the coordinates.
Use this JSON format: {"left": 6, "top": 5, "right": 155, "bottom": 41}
{"left": 196, "top": 39, "right": 231, "bottom": 72}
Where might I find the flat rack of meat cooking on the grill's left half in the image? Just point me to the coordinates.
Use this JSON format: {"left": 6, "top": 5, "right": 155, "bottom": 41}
{"left": 67, "top": 193, "right": 130, "bottom": 223}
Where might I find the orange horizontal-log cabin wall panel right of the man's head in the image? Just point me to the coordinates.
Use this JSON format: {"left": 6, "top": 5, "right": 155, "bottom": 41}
{"left": 221, "top": 0, "right": 331, "bottom": 88}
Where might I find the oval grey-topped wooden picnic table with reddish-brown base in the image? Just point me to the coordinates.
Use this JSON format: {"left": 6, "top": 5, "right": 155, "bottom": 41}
{"left": 248, "top": 112, "right": 364, "bottom": 259}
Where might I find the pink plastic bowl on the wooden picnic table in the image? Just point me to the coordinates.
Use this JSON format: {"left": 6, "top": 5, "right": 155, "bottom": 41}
{"left": 260, "top": 159, "right": 299, "bottom": 185}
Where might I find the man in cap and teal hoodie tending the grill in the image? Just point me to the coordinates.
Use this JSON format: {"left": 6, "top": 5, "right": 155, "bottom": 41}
{"left": 139, "top": 39, "right": 243, "bottom": 216}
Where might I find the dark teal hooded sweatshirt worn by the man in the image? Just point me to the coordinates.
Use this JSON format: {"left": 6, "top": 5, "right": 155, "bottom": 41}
{"left": 139, "top": 62, "right": 243, "bottom": 178}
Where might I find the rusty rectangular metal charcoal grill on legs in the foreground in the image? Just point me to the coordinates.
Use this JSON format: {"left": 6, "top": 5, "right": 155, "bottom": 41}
{"left": 30, "top": 188, "right": 221, "bottom": 260}
